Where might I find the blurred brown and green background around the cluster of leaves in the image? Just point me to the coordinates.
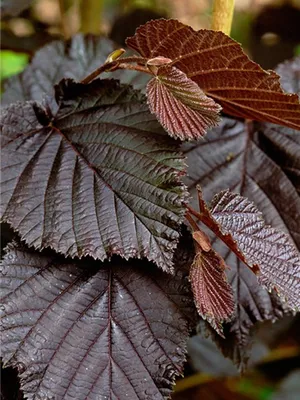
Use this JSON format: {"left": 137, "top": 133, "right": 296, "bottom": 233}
{"left": 1, "top": 0, "right": 300, "bottom": 400}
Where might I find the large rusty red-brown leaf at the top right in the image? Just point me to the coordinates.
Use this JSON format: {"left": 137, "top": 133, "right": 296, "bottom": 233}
{"left": 126, "top": 19, "right": 300, "bottom": 129}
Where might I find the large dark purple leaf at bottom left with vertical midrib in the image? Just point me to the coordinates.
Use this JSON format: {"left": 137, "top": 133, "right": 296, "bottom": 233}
{"left": 0, "top": 241, "right": 194, "bottom": 400}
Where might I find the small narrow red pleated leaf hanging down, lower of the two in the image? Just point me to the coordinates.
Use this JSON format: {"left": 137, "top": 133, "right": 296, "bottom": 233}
{"left": 190, "top": 239, "right": 234, "bottom": 337}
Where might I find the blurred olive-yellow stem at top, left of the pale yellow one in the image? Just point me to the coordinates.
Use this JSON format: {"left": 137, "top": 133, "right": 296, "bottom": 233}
{"left": 80, "top": 0, "right": 103, "bottom": 35}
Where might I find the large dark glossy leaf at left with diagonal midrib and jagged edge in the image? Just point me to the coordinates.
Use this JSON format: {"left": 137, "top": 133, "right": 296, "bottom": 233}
{"left": 1, "top": 80, "right": 186, "bottom": 271}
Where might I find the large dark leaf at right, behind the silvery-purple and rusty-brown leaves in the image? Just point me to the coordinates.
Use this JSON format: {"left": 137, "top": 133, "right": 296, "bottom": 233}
{"left": 184, "top": 57, "right": 300, "bottom": 368}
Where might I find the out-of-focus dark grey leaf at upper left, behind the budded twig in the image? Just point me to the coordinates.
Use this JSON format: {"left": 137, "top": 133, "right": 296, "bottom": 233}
{"left": 2, "top": 34, "right": 148, "bottom": 104}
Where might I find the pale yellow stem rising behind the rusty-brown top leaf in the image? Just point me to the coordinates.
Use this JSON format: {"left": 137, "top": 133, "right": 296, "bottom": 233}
{"left": 211, "top": 0, "right": 234, "bottom": 35}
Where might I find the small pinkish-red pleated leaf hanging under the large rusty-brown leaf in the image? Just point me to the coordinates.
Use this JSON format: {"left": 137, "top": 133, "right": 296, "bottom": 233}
{"left": 147, "top": 65, "right": 221, "bottom": 140}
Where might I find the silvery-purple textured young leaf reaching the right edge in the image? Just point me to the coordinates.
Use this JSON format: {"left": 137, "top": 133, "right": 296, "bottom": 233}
{"left": 206, "top": 191, "right": 300, "bottom": 309}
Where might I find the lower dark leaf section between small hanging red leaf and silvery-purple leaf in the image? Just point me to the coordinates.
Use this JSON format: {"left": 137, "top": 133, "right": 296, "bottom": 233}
{"left": 198, "top": 241, "right": 292, "bottom": 372}
